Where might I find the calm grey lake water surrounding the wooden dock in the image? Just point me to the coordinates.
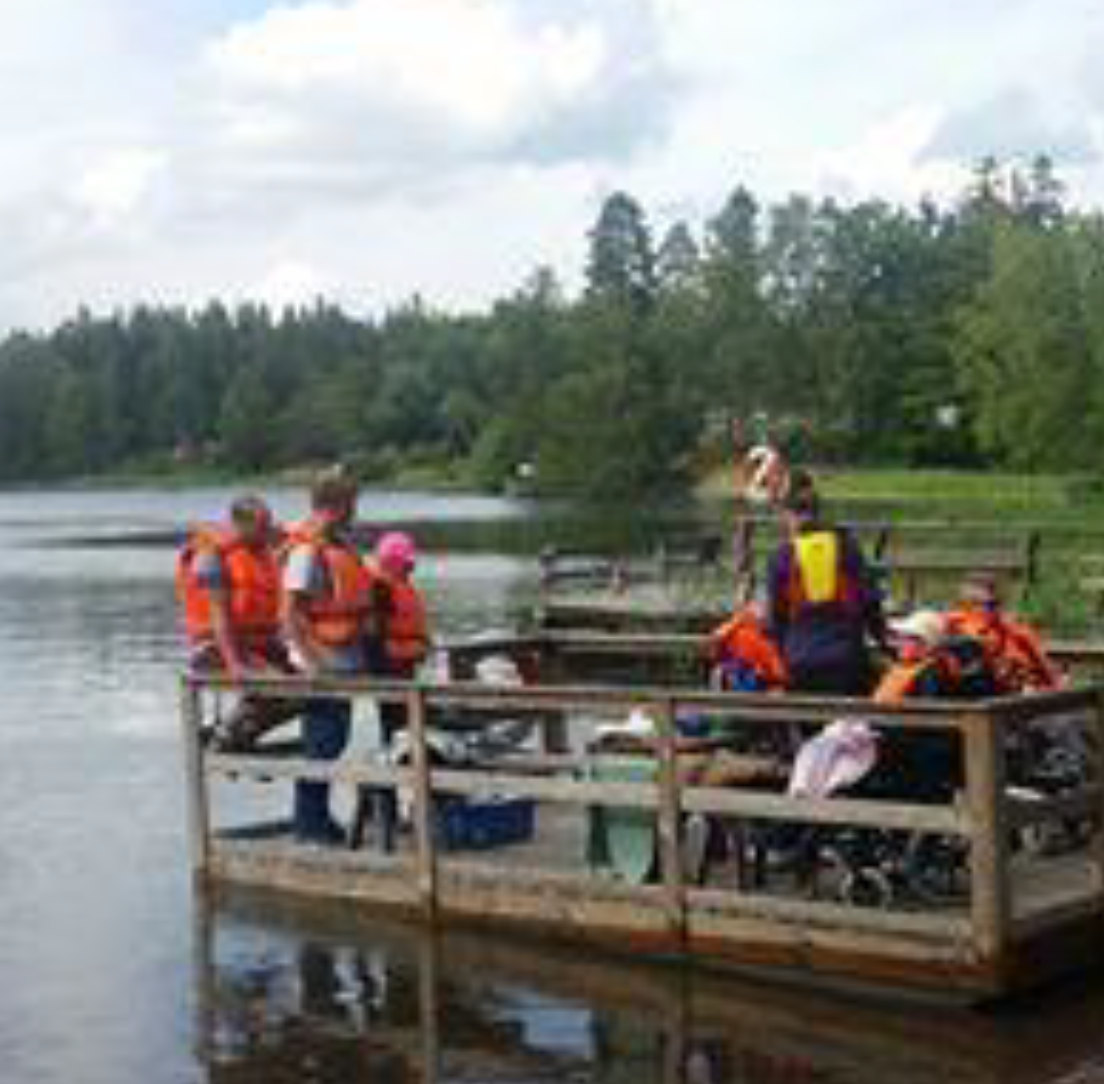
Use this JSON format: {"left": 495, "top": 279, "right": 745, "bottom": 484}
{"left": 0, "top": 489, "right": 1104, "bottom": 1084}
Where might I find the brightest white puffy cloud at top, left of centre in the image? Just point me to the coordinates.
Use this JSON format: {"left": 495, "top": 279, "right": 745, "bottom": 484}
{"left": 209, "top": 0, "right": 605, "bottom": 135}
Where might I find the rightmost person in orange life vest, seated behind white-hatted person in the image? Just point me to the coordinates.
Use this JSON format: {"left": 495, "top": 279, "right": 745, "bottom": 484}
{"left": 947, "top": 573, "right": 1064, "bottom": 693}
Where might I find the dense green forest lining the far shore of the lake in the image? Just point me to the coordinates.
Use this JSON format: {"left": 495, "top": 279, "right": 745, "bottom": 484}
{"left": 0, "top": 157, "right": 1104, "bottom": 499}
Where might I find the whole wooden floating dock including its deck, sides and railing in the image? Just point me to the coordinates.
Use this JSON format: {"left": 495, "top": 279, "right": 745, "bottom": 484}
{"left": 182, "top": 637, "right": 1104, "bottom": 1000}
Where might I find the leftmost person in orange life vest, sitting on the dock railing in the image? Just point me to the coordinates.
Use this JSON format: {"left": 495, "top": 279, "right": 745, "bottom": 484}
{"left": 177, "top": 495, "right": 302, "bottom": 752}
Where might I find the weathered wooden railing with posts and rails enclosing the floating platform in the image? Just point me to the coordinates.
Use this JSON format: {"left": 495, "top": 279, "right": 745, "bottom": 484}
{"left": 176, "top": 666, "right": 1104, "bottom": 1006}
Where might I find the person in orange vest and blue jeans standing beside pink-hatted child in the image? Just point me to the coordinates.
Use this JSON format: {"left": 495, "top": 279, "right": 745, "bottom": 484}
{"left": 284, "top": 470, "right": 370, "bottom": 844}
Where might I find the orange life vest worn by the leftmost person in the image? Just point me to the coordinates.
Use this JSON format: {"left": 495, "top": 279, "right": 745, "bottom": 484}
{"left": 177, "top": 524, "right": 280, "bottom": 641}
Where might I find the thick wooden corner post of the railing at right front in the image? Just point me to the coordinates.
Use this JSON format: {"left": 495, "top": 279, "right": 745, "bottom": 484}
{"left": 963, "top": 711, "right": 1011, "bottom": 966}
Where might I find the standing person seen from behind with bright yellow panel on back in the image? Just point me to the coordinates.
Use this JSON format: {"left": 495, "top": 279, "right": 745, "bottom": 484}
{"left": 767, "top": 471, "right": 885, "bottom": 695}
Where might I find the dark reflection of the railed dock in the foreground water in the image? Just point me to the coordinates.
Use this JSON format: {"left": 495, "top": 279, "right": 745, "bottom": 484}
{"left": 197, "top": 891, "right": 1104, "bottom": 1084}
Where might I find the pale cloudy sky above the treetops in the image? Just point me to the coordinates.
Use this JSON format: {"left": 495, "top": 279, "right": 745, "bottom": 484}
{"left": 0, "top": 0, "right": 1104, "bottom": 330}
